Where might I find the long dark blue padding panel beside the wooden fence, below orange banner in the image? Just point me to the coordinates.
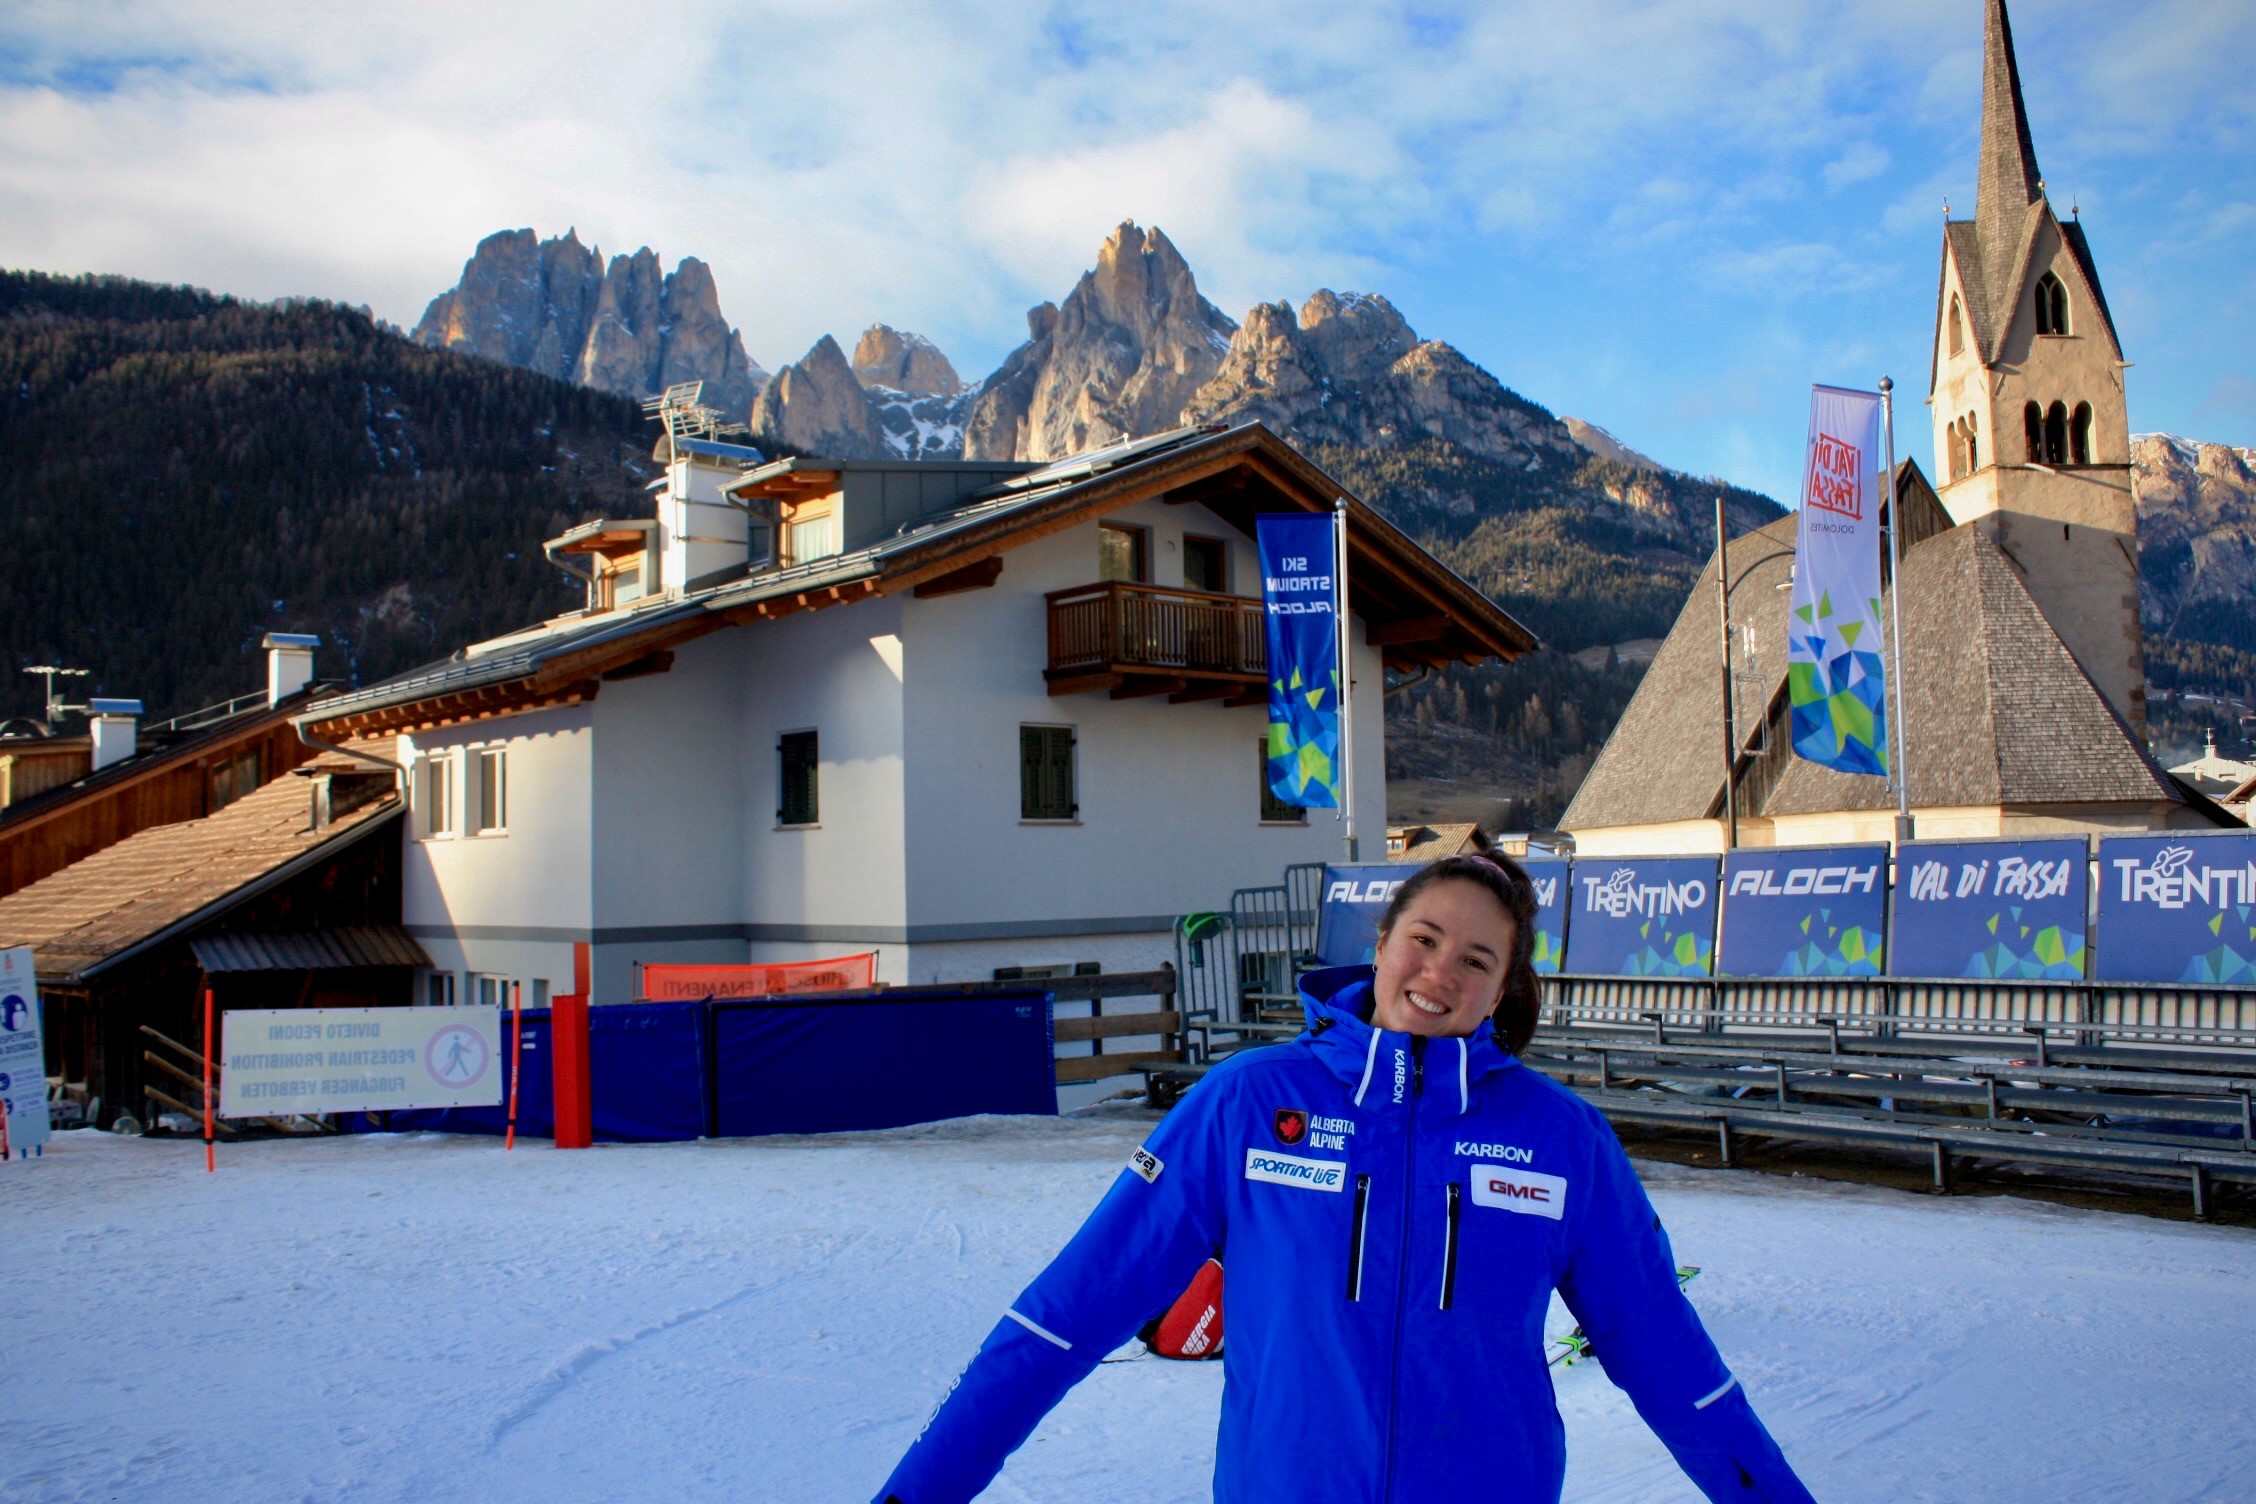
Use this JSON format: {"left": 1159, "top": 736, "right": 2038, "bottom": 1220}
{"left": 713, "top": 990, "right": 1058, "bottom": 1139}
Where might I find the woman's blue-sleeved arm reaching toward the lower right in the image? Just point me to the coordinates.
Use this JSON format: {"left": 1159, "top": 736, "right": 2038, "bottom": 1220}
{"left": 1559, "top": 1127, "right": 1814, "bottom": 1504}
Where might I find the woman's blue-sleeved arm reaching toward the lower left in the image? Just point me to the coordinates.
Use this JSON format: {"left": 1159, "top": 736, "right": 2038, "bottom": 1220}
{"left": 878, "top": 1078, "right": 1227, "bottom": 1504}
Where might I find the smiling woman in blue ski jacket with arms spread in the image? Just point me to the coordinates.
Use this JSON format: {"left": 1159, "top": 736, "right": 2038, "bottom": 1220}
{"left": 878, "top": 857, "right": 1809, "bottom": 1504}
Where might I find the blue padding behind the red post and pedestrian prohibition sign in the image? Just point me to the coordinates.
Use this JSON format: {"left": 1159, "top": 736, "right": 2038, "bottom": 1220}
{"left": 347, "top": 1003, "right": 706, "bottom": 1143}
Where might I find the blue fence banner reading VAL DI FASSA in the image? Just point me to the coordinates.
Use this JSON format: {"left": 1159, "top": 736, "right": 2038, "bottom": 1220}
{"left": 1888, "top": 837, "right": 2089, "bottom": 981}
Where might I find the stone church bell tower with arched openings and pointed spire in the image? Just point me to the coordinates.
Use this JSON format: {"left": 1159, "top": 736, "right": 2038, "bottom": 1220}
{"left": 1929, "top": 0, "right": 2145, "bottom": 740}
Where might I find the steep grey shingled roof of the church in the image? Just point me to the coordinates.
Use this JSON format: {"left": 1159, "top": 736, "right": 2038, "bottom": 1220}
{"left": 1559, "top": 465, "right": 2188, "bottom": 830}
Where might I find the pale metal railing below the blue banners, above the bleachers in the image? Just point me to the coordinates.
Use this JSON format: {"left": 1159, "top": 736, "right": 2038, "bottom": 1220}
{"left": 1543, "top": 974, "right": 2256, "bottom": 1049}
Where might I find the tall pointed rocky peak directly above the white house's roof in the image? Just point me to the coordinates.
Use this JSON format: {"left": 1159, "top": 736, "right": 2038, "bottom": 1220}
{"left": 963, "top": 223, "right": 1236, "bottom": 460}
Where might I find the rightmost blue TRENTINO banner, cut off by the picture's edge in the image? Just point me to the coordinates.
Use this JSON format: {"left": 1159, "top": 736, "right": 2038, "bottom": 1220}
{"left": 2098, "top": 832, "right": 2256, "bottom": 985}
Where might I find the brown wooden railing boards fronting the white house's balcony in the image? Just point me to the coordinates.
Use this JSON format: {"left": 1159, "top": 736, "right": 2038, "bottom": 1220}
{"left": 1045, "top": 580, "right": 1268, "bottom": 681}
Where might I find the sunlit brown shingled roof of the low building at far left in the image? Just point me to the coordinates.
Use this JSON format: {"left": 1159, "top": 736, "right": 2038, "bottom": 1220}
{"left": 0, "top": 744, "right": 402, "bottom": 983}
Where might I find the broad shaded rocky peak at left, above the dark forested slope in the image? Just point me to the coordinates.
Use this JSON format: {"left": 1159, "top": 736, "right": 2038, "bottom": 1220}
{"left": 413, "top": 230, "right": 767, "bottom": 417}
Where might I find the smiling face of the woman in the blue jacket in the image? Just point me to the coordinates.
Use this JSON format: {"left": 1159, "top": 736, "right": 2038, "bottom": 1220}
{"left": 1372, "top": 879, "right": 1518, "bottom": 1035}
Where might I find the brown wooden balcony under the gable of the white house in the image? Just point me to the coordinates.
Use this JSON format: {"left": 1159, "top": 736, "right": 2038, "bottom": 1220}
{"left": 1042, "top": 580, "right": 1268, "bottom": 706}
